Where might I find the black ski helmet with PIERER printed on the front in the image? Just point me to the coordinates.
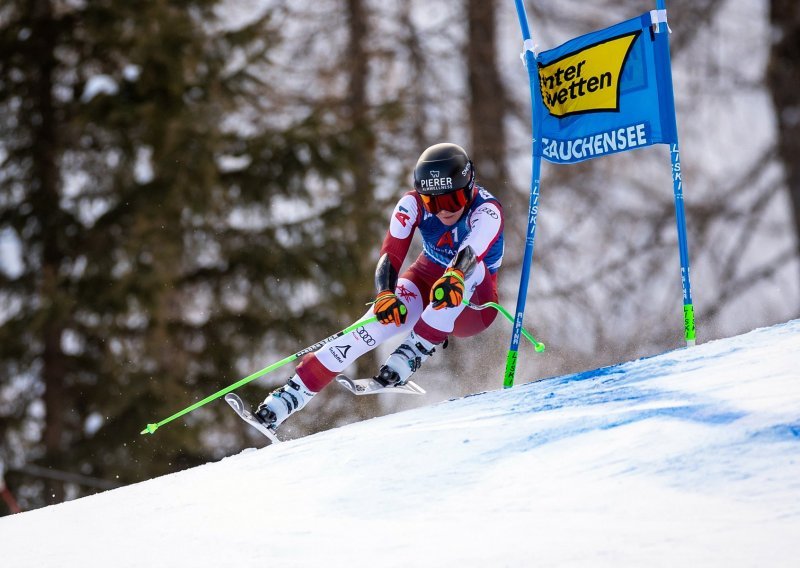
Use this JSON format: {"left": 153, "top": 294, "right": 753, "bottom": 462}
{"left": 414, "top": 142, "right": 475, "bottom": 198}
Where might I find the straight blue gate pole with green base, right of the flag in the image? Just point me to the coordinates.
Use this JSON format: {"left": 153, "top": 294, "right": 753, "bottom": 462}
{"left": 655, "top": 0, "right": 696, "bottom": 346}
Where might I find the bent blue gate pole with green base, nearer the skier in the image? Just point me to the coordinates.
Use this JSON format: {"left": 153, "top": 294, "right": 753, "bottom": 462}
{"left": 503, "top": 0, "right": 542, "bottom": 388}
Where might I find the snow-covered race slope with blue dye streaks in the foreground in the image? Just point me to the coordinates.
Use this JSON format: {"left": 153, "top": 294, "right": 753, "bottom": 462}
{"left": 0, "top": 320, "right": 800, "bottom": 568}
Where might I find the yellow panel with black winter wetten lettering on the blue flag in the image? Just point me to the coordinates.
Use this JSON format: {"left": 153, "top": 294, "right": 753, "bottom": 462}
{"left": 539, "top": 30, "right": 642, "bottom": 118}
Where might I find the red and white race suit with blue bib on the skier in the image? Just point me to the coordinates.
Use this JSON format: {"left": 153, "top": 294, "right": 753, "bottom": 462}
{"left": 297, "top": 185, "right": 503, "bottom": 392}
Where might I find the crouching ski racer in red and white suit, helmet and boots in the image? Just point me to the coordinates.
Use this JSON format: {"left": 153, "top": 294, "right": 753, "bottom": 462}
{"left": 255, "top": 143, "right": 503, "bottom": 430}
